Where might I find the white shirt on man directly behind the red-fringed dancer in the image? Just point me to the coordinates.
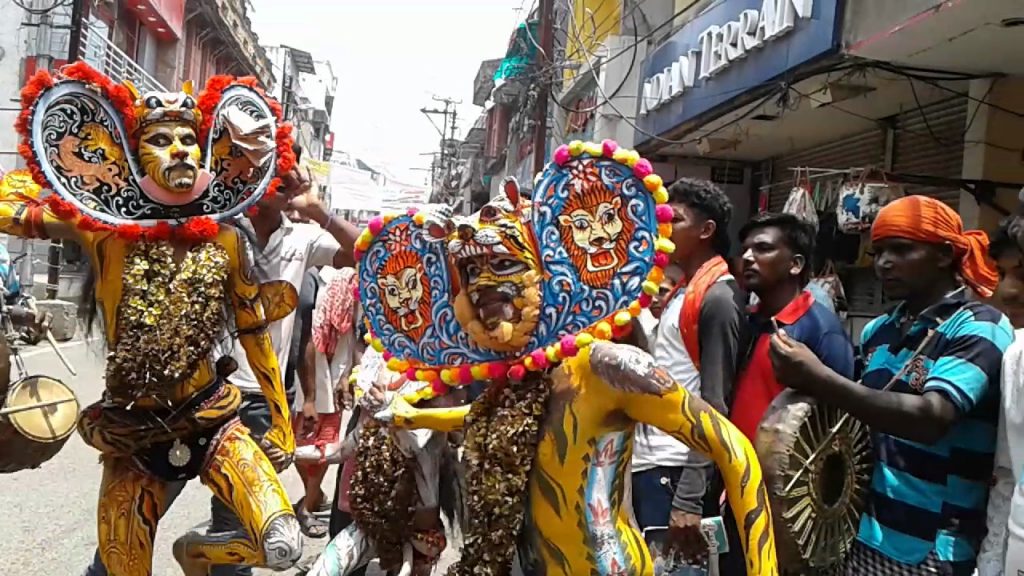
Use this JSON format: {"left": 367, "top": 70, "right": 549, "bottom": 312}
{"left": 228, "top": 216, "right": 341, "bottom": 394}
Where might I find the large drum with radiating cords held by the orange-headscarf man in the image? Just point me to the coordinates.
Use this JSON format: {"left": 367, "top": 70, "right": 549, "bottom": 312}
{"left": 755, "top": 389, "right": 873, "bottom": 574}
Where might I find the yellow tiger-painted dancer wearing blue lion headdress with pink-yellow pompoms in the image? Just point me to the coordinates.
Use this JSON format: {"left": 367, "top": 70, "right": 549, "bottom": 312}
{"left": 356, "top": 141, "right": 777, "bottom": 576}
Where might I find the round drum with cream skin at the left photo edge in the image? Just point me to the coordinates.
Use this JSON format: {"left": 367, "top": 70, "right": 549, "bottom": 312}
{"left": 0, "top": 376, "right": 79, "bottom": 474}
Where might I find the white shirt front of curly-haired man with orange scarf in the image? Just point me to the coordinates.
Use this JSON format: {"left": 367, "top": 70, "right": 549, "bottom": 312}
{"left": 632, "top": 290, "right": 700, "bottom": 472}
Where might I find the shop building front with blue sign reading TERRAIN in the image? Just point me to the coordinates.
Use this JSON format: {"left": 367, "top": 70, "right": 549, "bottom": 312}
{"left": 635, "top": 0, "right": 1024, "bottom": 335}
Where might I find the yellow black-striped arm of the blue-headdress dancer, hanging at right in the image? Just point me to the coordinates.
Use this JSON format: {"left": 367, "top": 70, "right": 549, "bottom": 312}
{"left": 581, "top": 342, "right": 778, "bottom": 576}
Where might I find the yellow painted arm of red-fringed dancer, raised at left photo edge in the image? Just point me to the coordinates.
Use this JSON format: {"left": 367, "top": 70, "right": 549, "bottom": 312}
{"left": 0, "top": 170, "right": 80, "bottom": 244}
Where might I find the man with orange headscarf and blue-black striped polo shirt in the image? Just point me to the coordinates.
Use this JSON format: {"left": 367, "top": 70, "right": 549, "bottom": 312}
{"left": 771, "top": 196, "right": 1014, "bottom": 576}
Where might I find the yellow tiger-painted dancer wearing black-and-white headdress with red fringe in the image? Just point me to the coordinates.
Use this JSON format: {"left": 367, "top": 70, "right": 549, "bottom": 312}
{"left": 0, "top": 63, "right": 354, "bottom": 576}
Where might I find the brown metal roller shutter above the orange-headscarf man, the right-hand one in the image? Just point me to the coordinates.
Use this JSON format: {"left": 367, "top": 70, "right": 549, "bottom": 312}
{"left": 892, "top": 96, "right": 968, "bottom": 209}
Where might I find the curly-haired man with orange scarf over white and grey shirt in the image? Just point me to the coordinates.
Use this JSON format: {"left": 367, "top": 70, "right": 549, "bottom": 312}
{"left": 633, "top": 178, "right": 746, "bottom": 564}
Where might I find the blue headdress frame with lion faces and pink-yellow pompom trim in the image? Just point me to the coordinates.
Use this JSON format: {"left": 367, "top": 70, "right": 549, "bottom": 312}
{"left": 355, "top": 140, "right": 675, "bottom": 401}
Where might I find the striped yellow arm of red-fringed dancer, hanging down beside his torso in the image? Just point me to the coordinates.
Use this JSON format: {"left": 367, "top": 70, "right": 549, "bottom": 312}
{"left": 221, "top": 228, "right": 295, "bottom": 454}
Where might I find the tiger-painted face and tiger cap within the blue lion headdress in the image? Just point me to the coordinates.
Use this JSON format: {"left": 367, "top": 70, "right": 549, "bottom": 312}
{"left": 446, "top": 180, "right": 542, "bottom": 352}
